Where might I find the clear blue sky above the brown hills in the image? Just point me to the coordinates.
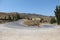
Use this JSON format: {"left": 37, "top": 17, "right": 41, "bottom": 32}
{"left": 0, "top": 0, "right": 60, "bottom": 16}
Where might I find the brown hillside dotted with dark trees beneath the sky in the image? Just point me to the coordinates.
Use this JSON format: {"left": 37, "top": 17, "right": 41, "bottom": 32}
{"left": 0, "top": 12, "right": 54, "bottom": 23}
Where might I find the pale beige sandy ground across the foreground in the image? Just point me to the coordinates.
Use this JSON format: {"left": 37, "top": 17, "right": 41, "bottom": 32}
{"left": 0, "top": 19, "right": 60, "bottom": 40}
